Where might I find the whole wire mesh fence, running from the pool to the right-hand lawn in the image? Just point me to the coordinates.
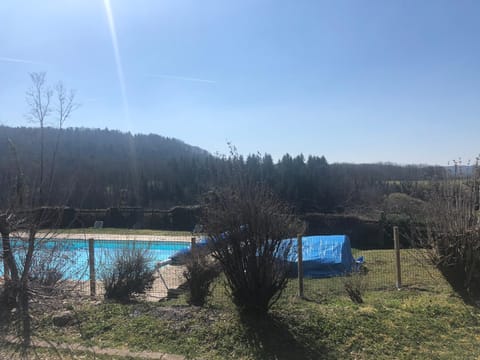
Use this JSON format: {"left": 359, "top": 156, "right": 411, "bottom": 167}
{"left": 0, "top": 232, "right": 442, "bottom": 301}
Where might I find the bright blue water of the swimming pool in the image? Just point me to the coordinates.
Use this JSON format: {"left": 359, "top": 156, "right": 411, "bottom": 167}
{"left": 0, "top": 239, "right": 190, "bottom": 280}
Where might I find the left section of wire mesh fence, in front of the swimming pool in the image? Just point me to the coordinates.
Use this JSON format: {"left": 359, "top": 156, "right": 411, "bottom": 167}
{"left": 0, "top": 232, "right": 192, "bottom": 300}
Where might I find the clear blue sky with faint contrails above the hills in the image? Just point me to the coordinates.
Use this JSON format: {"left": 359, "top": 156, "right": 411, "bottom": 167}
{"left": 0, "top": 0, "right": 480, "bottom": 164}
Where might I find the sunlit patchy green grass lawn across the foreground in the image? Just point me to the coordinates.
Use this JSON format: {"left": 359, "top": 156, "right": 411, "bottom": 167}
{"left": 18, "top": 250, "right": 480, "bottom": 359}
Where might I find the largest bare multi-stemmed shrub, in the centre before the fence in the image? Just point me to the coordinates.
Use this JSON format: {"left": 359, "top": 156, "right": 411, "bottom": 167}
{"left": 202, "top": 179, "right": 301, "bottom": 315}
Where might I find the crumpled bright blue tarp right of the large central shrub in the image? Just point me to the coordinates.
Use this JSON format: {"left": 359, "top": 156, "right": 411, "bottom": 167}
{"left": 289, "top": 235, "right": 356, "bottom": 278}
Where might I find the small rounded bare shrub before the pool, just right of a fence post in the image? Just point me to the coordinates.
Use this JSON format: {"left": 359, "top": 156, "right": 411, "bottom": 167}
{"left": 100, "top": 247, "right": 155, "bottom": 301}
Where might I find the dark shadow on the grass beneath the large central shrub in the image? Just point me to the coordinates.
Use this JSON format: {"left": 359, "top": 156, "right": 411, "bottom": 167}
{"left": 241, "top": 314, "right": 332, "bottom": 360}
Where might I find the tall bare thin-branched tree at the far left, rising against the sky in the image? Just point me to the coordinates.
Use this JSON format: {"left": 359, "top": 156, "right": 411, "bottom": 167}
{"left": 0, "top": 73, "right": 77, "bottom": 354}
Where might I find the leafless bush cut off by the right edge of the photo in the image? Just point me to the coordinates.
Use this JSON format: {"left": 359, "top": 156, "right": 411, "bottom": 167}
{"left": 417, "top": 178, "right": 480, "bottom": 298}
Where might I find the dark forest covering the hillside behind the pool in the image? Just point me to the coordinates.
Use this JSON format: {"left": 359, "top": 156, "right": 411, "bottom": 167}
{"left": 0, "top": 126, "right": 445, "bottom": 213}
